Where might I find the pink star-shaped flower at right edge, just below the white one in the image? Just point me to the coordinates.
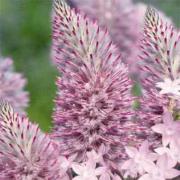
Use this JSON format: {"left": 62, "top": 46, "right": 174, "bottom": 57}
{"left": 152, "top": 111, "right": 180, "bottom": 146}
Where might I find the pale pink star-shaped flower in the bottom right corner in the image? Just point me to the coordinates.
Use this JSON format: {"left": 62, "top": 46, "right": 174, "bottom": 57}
{"left": 139, "top": 155, "right": 180, "bottom": 180}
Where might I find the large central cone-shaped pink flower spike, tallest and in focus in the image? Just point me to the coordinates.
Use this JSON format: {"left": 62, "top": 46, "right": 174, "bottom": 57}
{"left": 53, "top": 0, "right": 159, "bottom": 166}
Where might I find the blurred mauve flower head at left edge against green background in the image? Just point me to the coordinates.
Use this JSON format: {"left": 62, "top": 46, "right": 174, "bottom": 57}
{"left": 0, "top": 57, "right": 29, "bottom": 114}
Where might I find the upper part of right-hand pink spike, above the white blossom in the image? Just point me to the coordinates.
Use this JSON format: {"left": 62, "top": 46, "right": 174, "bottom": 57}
{"left": 141, "top": 7, "right": 180, "bottom": 87}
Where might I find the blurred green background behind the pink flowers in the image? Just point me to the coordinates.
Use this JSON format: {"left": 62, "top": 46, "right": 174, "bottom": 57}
{"left": 0, "top": 0, "right": 180, "bottom": 131}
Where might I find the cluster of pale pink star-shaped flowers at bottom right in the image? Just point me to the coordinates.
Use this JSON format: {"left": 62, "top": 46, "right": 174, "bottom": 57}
{"left": 121, "top": 112, "right": 180, "bottom": 180}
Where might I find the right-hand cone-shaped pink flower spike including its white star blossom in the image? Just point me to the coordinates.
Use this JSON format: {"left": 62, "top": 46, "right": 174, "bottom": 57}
{"left": 140, "top": 8, "right": 180, "bottom": 118}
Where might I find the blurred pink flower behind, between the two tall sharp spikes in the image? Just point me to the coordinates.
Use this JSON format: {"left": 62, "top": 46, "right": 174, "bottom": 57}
{"left": 67, "top": 0, "right": 146, "bottom": 75}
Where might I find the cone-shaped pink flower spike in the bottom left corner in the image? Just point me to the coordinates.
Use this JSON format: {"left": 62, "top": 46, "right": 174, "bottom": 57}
{"left": 0, "top": 103, "right": 63, "bottom": 180}
